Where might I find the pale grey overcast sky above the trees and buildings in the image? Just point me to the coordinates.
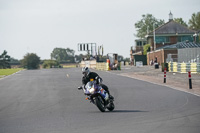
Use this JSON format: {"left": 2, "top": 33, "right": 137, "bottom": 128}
{"left": 0, "top": 0, "right": 200, "bottom": 59}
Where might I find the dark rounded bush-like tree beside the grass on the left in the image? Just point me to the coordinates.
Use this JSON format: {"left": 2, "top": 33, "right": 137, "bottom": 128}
{"left": 21, "top": 53, "right": 40, "bottom": 69}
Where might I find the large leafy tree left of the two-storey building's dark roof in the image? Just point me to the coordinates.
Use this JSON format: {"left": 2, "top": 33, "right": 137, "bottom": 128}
{"left": 135, "top": 14, "right": 165, "bottom": 38}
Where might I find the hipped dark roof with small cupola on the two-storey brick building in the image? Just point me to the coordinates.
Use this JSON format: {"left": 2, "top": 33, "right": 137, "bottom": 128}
{"left": 149, "top": 20, "right": 195, "bottom": 35}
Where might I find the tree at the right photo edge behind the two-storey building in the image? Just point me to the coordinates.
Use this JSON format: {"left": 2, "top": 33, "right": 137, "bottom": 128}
{"left": 188, "top": 12, "right": 200, "bottom": 30}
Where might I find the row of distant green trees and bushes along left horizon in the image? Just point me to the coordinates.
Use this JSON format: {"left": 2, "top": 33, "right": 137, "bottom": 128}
{"left": 0, "top": 48, "right": 84, "bottom": 69}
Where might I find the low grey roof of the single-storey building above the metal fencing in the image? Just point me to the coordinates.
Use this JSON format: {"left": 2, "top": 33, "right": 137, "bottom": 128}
{"left": 157, "top": 42, "right": 200, "bottom": 50}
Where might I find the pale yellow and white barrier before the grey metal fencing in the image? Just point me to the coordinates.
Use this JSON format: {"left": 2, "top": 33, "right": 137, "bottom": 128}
{"left": 168, "top": 62, "right": 200, "bottom": 73}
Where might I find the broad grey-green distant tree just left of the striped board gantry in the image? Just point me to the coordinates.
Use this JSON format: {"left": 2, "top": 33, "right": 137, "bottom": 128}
{"left": 51, "top": 48, "right": 75, "bottom": 62}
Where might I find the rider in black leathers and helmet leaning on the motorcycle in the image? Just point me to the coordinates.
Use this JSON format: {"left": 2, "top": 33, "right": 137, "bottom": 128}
{"left": 78, "top": 67, "right": 113, "bottom": 99}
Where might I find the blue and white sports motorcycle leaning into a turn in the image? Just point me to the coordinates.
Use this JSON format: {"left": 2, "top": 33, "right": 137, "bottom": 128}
{"left": 82, "top": 81, "right": 115, "bottom": 112}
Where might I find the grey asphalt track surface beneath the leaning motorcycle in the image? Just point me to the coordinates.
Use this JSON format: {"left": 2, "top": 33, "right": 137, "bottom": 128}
{"left": 0, "top": 68, "right": 200, "bottom": 133}
